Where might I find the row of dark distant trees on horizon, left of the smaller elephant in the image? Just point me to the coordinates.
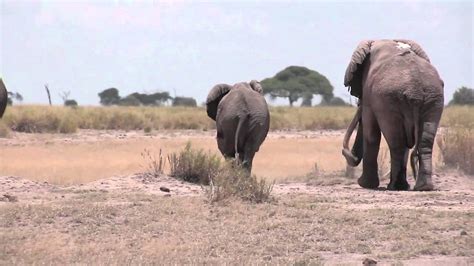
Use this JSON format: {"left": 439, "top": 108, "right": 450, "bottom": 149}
{"left": 98, "top": 88, "right": 197, "bottom": 107}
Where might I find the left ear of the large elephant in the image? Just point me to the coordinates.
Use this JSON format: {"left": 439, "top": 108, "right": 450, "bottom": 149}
{"left": 344, "top": 40, "right": 373, "bottom": 98}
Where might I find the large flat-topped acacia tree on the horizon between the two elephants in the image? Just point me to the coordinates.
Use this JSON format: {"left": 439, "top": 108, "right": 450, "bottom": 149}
{"left": 261, "top": 66, "right": 333, "bottom": 106}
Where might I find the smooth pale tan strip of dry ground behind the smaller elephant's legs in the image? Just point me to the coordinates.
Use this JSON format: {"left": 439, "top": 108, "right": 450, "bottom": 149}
{"left": 0, "top": 131, "right": 352, "bottom": 184}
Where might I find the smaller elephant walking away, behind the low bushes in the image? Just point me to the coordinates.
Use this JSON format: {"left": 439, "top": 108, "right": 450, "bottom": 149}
{"left": 206, "top": 80, "right": 270, "bottom": 173}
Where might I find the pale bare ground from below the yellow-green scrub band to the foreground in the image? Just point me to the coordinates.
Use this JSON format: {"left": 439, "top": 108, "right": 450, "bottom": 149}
{"left": 0, "top": 131, "right": 474, "bottom": 265}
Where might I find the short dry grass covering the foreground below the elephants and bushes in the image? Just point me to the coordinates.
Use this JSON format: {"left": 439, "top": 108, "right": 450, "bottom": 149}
{"left": 0, "top": 192, "right": 474, "bottom": 265}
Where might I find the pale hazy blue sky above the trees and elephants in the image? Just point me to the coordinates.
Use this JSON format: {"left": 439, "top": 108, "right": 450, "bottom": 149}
{"left": 0, "top": 0, "right": 474, "bottom": 105}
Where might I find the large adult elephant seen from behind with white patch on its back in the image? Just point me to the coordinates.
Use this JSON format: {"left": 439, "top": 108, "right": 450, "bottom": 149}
{"left": 342, "top": 40, "right": 444, "bottom": 190}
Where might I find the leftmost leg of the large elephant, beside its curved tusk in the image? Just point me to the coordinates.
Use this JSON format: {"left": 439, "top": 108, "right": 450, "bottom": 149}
{"left": 357, "top": 106, "right": 381, "bottom": 189}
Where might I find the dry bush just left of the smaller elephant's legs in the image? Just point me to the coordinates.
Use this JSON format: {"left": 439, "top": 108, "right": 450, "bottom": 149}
{"left": 168, "top": 142, "right": 221, "bottom": 185}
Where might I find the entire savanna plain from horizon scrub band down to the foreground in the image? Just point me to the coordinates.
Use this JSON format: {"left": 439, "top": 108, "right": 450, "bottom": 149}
{"left": 0, "top": 106, "right": 474, "bottom": 265}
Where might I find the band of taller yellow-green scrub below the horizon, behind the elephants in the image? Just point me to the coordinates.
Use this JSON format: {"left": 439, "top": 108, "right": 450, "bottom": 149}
{"left": 3, "top": 105, "right": 474, "bottom": 133}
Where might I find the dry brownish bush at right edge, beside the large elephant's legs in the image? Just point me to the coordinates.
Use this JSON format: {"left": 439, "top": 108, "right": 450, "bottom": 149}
{"left": 437, "top": 127, "right": 474, "bottom": 175}
